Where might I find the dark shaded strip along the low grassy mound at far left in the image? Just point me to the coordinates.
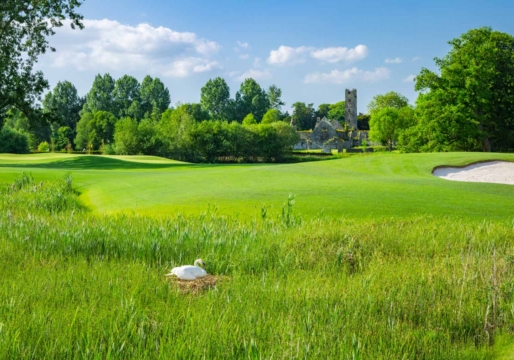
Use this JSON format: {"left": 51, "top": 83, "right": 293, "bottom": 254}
{"left": 0, "top": 155, "right": 201, "bottom": 170}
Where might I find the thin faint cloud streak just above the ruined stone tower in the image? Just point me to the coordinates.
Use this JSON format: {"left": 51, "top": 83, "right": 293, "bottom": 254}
{"left": 304, "top": 67, "right": 391, "bottom": 84}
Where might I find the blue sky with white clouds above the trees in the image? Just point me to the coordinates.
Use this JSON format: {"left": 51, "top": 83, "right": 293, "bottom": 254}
{"left": 39, "top": 0, "right": 514, "bottom": 113}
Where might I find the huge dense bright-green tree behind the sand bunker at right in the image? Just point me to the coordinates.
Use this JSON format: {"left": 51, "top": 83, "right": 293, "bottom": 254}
{"left": 412, "top": 27, "right": 514, "bottom": 151}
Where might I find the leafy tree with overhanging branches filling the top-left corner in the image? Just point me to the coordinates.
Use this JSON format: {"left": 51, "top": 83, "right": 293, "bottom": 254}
{"left": 0, "top": 0, "right": 83, "bottom": 122}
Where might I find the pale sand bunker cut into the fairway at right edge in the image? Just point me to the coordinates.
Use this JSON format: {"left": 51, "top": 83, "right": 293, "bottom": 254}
{"left": 433, "top": 161, "right": 514, "bottom": 185}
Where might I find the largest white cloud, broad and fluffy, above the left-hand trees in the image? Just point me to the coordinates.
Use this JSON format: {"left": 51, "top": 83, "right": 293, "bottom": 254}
{"left": 50, "top": 19, "right": 220, "bottom": 77}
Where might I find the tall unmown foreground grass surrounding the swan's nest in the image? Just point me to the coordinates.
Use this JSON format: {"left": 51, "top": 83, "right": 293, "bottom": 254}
{"left": 0, "top": 175, "right": 514, "bottom": 359}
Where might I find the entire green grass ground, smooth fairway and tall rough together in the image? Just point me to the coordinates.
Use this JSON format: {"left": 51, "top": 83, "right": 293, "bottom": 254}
{"left": 0, "top": 153, "right": 514, "bottom": 359}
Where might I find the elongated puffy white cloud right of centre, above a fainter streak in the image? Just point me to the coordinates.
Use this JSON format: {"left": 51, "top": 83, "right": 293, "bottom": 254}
{"left": 268, "top": 45, "right": 368, "bottom": 65}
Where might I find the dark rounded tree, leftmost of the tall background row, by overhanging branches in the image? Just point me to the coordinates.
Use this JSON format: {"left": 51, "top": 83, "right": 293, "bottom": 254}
{"left": 43, "top": 81, "right": 85, "bottom": 129}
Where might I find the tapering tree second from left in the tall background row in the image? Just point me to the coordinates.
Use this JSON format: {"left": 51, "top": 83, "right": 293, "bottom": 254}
{"left": 82, "top": 74, "right": 117, "bottom": 114}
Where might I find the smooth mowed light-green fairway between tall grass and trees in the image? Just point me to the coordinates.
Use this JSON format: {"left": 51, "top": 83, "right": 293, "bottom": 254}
{"left": 0, "top": 153, "right": 514, "bottom": 219}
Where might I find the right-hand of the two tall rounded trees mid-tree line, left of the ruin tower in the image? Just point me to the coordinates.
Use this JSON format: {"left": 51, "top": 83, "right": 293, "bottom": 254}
{"left": 235, "top": 78, "right": 270, "bottom": 122}
